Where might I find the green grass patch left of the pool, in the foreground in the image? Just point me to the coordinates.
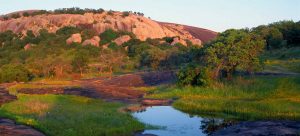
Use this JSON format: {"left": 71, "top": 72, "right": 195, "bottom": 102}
{"left": 0, "top": 94, "right": 145, "bottom": 136}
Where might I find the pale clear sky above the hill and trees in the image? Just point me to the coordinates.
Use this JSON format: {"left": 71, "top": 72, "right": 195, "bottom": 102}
{"left": 0, "top": 0, "right": 300, "bottom": 32}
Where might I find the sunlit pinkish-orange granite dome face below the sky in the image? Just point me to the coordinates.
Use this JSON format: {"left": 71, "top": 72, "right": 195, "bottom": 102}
{"left": 0, "top": 11, "right": 217, "bottom": 45}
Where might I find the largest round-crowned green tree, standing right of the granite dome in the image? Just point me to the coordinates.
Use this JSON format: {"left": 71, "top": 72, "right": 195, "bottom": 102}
{"left": 205, "top": 29, "right": 265, "bottom": 80}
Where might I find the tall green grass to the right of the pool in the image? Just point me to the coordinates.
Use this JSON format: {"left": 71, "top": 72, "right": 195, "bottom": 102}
{"left": 147, "top": 76, "right": 300, "bottom": 120}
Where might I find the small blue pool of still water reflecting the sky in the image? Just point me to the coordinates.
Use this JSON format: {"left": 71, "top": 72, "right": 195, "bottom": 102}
{"left": 133, "top": 106, "right": 222, "bottom": 136}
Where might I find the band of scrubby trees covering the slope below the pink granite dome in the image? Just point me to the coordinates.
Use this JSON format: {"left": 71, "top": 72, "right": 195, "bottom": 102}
{"left": 0, "top": 26, "right": 197, "bottom": 82}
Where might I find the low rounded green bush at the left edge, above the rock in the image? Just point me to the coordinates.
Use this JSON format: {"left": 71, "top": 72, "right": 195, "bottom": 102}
{"left": 0, "top": 64, "right": 32, "bottom": 83}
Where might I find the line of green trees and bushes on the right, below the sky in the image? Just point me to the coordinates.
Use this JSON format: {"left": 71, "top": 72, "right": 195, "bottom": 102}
{"left": 178, "top": 21, "right": 300, "bottom": 86}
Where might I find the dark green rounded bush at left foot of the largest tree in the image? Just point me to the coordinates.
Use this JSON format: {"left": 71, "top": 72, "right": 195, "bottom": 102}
{"left": 177, "top": 64, "right": 211, "bottom": 86}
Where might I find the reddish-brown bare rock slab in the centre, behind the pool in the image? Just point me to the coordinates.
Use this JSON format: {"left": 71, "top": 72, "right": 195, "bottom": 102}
{"left": 18, "top": 72, "right": 175, "bottom": 105}
